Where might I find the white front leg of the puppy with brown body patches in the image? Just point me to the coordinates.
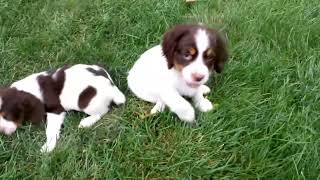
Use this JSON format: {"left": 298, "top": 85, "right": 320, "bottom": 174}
{"left": 41, "top": 112, "right": 65, "bottom": 153}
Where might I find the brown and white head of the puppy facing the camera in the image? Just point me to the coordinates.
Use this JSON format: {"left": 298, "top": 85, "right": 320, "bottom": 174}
{"left": 162, "top": 25, "right": 228, "bottom": 87}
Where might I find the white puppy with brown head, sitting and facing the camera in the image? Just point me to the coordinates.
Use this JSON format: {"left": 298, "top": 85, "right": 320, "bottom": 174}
{"left": 127, "top": 25, "right": 228, "bottom": 122}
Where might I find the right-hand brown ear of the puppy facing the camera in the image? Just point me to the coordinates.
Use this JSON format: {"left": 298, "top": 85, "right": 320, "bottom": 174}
{"left": 213, "top": 33, "right": 229, "bottom": 73}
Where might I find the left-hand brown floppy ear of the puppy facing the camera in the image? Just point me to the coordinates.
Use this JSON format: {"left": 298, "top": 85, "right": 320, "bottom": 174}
{"left": 162, "top": 25, "right": 190, "bottom": 69}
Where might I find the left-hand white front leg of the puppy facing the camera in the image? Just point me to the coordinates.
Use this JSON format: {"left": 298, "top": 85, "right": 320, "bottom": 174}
{"left": 161, "top": 90, "right": 195, "bottom": 123}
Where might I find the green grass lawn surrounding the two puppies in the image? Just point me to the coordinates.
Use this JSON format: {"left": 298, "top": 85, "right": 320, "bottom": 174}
{"left": 0, "top": 0, "right": 320, "bottom": 179}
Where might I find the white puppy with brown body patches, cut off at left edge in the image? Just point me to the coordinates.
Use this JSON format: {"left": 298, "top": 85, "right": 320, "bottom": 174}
{"left": 0, "top": 64, "right": 125, "bottom": 152}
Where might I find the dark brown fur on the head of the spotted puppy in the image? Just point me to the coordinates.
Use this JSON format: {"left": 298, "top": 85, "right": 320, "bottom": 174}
{"left": 0, "top": 88, "right": 45, "bottom": 126}
